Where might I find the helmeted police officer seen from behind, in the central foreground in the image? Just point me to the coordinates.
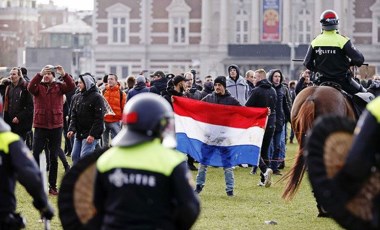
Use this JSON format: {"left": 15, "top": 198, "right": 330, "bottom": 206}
{"left": 94, "top": 93, "right": 200, "bottom": 229}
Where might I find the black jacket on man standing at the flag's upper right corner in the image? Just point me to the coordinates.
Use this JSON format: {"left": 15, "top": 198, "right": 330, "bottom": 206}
{"left": 245, "top": 79, "right": 277, "bottom": 128}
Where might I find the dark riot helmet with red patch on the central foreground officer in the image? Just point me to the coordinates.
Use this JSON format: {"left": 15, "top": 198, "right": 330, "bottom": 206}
{"left": 112, "top": 93, "right": 174, "bottom": 146}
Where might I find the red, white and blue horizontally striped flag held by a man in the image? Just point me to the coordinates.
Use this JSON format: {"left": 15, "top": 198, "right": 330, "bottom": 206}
{"left": 173, "top": 97, "right": 268, "bottom": 167}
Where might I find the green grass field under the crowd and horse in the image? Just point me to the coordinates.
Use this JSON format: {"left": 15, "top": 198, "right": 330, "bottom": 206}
{"left": 17, "top": 144, "right": 341, "bottom": 229}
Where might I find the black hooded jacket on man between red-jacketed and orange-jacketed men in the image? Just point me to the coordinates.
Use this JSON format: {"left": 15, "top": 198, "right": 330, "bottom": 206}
{"left": 69, "top": 87, "right": 105, "bottom": 140}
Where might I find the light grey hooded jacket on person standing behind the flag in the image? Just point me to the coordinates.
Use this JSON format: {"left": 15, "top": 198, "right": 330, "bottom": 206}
{"left": 226, "top": 65, "right": 249, "bottom": 105}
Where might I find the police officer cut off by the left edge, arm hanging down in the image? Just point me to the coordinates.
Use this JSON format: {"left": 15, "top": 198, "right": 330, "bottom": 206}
{"left": 0, "top": 97, "right": 54, "bottom": 230}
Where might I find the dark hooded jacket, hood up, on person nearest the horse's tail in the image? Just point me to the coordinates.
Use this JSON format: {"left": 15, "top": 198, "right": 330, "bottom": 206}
{"left": 267, "top": 69, "right": 291, "bottom": 132}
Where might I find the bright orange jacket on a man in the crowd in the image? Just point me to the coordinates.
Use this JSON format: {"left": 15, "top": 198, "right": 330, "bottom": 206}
{"left": 103, "top": 85, "right": 127, "bottom": 122}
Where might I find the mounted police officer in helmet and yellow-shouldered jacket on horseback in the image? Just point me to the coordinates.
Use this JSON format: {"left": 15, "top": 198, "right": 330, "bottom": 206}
{"left": 303, "top": 10, "right": 365, "bottom": 95}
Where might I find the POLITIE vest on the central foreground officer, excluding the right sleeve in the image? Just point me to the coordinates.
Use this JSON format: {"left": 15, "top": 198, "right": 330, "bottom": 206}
{"left": 94, "top": 140, "right": 186, "bottom": 229}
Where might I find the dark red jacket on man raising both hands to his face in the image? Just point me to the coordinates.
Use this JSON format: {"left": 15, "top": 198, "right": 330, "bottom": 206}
{"left": 28, "top": 73, "right": 75, "bottom": 129}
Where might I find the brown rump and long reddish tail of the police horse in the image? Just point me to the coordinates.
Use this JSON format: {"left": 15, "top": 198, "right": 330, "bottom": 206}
{"left": 281, "top": 86, "right": 355, "bottom": 200}
